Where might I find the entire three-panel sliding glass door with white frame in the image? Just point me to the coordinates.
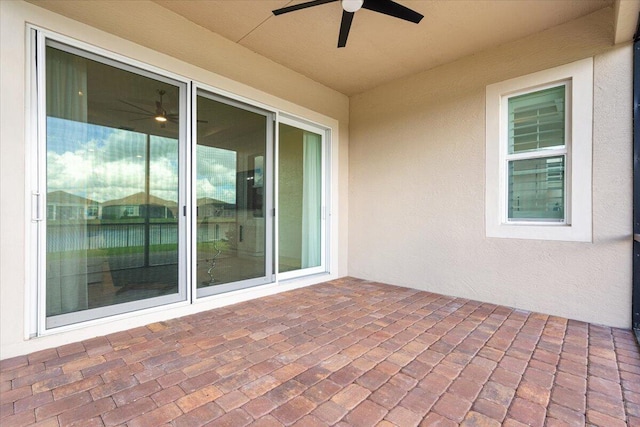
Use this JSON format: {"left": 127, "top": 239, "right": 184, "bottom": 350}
{"left": 37, "top": 31, "right": 327, "bottom": 333}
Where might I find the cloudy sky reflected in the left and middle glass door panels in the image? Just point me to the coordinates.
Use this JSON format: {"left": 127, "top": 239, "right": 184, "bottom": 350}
{"left": 47, "top": 117, "right": 236, "bottom": 203}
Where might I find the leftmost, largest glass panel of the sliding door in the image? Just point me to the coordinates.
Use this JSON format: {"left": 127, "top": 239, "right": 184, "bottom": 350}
{"left": 45, "top": 42, "right": 186, "bottom": 328}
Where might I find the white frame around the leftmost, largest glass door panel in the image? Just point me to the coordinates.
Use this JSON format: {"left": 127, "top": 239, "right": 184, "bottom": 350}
{"left": 30, "top": 27, "right": 191, "bottom": 335}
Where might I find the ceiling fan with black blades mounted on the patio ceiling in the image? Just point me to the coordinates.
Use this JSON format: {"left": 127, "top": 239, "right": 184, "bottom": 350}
{"left": 273, "top": 0, "right": 424, "bottom": 47}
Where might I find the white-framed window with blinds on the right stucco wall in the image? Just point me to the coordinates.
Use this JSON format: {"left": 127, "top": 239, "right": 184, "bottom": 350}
{"left": 486, "top": 58, "right": 593, "bottom": 241}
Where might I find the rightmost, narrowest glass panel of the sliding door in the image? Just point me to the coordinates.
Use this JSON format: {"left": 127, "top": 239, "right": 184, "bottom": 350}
{"left": 278, "top": 123, "right": 324, "bottom": 278}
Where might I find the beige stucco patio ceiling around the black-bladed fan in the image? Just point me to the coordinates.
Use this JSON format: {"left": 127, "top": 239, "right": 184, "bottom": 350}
{"left": 29, "top": 0, "right": 640, "bottom": 95}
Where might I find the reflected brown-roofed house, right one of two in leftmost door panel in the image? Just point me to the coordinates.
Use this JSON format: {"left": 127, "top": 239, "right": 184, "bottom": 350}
{"left": 101, "top": 192, "right": 178, "bottom": 219}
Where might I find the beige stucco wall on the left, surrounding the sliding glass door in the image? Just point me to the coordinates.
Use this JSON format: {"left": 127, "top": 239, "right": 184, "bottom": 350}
{"left": 0, "top": 1, "right": 349, "bottom": 359}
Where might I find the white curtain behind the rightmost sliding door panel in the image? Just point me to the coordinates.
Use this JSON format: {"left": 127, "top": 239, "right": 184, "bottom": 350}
{"left": 301, "top": 132, "right": 322, "bottom": 268}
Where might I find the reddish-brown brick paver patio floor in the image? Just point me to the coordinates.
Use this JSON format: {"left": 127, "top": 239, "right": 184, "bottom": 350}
{"left": 0, "top": 278, "right": 640, "bottom": 427}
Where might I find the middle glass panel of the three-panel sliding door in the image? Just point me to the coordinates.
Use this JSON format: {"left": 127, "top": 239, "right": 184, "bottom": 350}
{"left": 195, "top": 92, "right": 273, "bottom": 296}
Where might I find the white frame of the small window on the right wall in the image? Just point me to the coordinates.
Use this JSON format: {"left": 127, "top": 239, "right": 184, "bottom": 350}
{"left": 485, "top": 58, "right": 593, "bottom": 242}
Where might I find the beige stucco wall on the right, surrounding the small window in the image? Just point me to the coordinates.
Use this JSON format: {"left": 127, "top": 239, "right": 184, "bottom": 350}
{"left": 349, "top": 5, "right": 632, "bottom": 328}
